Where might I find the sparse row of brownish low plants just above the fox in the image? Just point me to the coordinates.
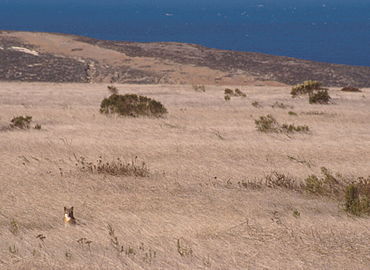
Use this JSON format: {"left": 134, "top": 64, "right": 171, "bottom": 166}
{"left": 76, "top": 156, "right": 149, "bottom": 177}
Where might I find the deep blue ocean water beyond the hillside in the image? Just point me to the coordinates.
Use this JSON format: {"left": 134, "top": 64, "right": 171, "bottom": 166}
{"left": 0, "top": 0, "right": 370, "bottom": 66}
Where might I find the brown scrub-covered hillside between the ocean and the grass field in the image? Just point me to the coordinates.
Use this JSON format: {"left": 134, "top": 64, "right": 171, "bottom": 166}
{"left": 0, "top": 31, "right": 370, "bottom": 87}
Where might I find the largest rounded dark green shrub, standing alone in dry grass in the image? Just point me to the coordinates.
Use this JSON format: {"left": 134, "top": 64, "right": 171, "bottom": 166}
{"left": 100, "top": 94, "right": 167, "bottom": 117}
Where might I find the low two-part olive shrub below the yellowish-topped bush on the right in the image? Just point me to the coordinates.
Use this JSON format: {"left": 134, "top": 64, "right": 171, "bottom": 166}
{"left": 255, "top": 114, "right": 310, "bottom": 133}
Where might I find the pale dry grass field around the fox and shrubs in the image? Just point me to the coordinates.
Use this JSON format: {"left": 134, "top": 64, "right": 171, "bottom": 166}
{"left": 0, "top": 82, "right": 370, "bottom": 269}
